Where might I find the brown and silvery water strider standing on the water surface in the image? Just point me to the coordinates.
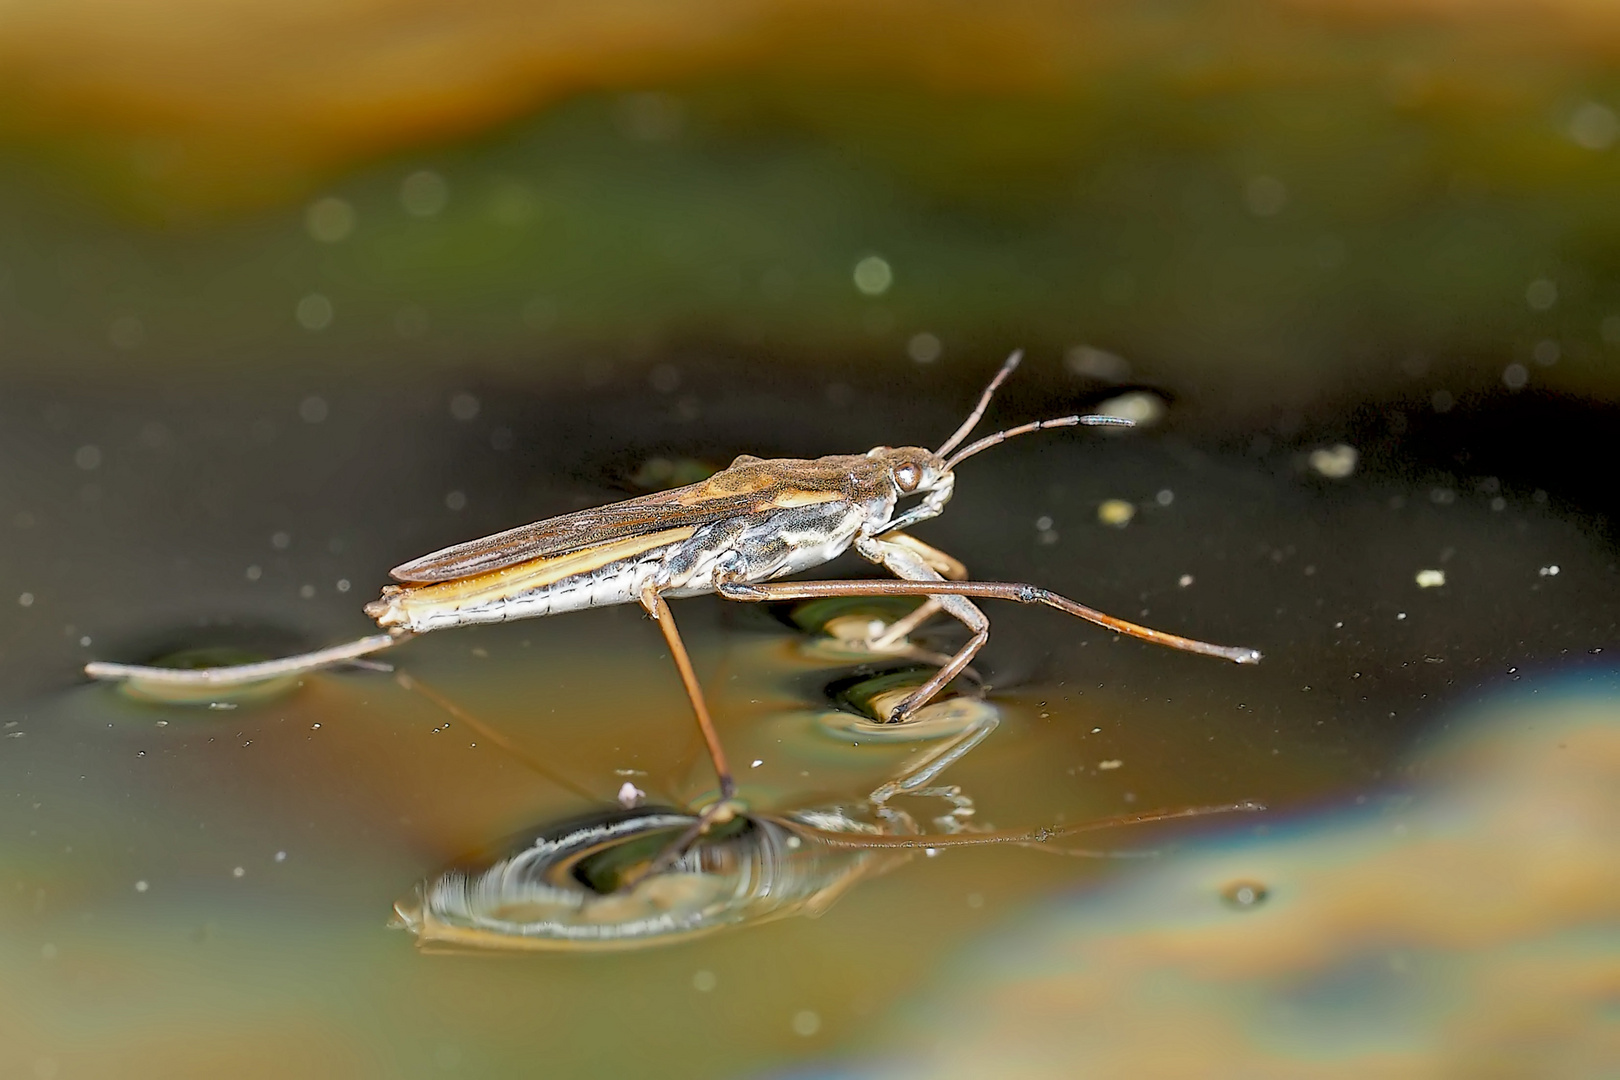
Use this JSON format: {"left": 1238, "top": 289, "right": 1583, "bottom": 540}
{"left": 84, "top": 353, "right": 1260, "bottom": 819}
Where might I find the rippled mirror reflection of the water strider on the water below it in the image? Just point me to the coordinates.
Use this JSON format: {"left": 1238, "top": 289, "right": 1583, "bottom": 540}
{"left": 394, "top": 660, "right": 1260, "bottom": 950}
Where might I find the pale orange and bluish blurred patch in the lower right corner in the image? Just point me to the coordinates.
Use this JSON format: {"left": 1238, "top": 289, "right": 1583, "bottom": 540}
{"left": 829, "top": 678, "right": 1620, "bottom": 1078}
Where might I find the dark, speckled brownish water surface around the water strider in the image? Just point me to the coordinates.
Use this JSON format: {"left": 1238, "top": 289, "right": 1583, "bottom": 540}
{"left": 0, "top": 355, "right": 1617, "bottom": 1077}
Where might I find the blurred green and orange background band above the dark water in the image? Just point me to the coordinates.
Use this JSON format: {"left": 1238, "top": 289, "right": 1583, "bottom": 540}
{"left": 9, "top": 0, "right": 1620, "bottom": 411}
